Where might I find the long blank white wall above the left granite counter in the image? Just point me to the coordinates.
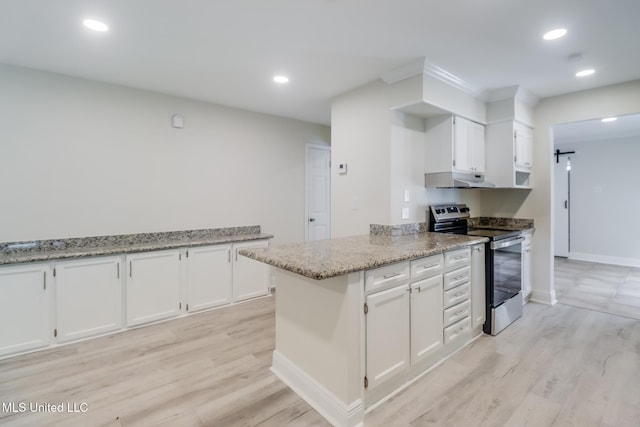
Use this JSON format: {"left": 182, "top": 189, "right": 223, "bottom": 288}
{"left": 0, "top": 64, "right": 330, "bottom": 242}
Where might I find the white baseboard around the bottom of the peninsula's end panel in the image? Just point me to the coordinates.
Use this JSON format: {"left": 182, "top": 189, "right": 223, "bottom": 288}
{"left": 271, "top": 350, "right": 364, "bottom": 427}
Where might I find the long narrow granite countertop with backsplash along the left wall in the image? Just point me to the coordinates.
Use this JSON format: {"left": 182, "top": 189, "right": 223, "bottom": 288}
{"left": 0, "top": 226, "right": 273, "bottom": 265}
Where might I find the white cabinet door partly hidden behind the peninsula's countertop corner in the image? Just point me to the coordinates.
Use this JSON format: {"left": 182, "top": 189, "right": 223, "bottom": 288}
{"left": 233, "top": 240, "right": 270, "bottom": 301}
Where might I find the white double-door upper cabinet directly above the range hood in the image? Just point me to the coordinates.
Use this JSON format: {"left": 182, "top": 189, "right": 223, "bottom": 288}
{"left": 425, "top": 115, "right": 485, "bottom": 174}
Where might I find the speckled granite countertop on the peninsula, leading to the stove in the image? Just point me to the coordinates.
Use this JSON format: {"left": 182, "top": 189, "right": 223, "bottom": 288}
{"left": 240, "top": 232, "right": 488, "bottom": 280}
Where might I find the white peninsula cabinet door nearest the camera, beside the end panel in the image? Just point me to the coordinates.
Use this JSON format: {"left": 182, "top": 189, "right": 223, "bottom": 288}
{"left": 366, "top": 284, "right": 410, "bottom": 388}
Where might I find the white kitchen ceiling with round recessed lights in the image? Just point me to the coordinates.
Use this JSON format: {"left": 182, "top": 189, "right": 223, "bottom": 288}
{"left": 0, "top": 0, "right": 640, "bottom": 124}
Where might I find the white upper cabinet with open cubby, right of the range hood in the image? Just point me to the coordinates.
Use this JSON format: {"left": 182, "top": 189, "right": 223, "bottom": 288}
{"left": 486, "top": 120, "right": 533, "bottom": 188}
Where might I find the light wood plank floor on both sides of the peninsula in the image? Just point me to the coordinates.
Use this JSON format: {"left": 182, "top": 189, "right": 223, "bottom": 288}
{"left": 0, "top": 286, "right": 640, "bottom": 427}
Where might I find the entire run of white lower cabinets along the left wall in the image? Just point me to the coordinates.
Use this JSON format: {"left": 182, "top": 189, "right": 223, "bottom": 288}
{"left": 0, "top": 240, "right": 270, "bottom": 357}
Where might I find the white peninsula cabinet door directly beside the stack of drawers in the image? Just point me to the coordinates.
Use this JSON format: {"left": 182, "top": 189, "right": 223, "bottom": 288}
{"left": 411, "top": 275, "right": 443, "bottom": 365}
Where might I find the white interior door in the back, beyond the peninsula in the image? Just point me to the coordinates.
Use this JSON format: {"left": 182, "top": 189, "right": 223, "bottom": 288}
{"left": 305, "top": 145, "right": 331, "bottom": 240}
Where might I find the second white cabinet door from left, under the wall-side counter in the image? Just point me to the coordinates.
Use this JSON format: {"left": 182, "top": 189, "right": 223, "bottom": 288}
{"left": 55, "top": 257, "right": 122, "bottom": 342}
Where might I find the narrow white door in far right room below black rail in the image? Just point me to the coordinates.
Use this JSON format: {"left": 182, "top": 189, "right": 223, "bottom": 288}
{"left": 554, "top": 157, "right": 571, "bottom": 257}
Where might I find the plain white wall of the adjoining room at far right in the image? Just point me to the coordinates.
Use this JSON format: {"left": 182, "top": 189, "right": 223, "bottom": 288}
{"left": 556, "top": 137, "right": 640, "bottom": 266}
